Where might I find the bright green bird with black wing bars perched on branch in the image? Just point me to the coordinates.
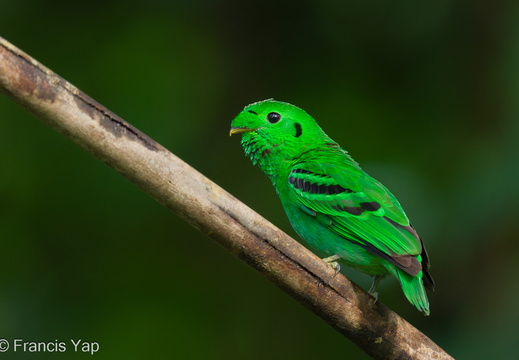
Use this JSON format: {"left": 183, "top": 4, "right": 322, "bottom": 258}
{"left": 230, "top": 99, "right": 434, "bottom": 315}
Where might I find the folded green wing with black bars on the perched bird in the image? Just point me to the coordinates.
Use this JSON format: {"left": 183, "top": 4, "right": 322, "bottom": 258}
{"left": 288, "top": 160, "right": 422, "bottom": 275}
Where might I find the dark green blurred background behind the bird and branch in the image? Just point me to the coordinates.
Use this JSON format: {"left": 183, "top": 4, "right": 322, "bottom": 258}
{"left": 0, "top": 0, "right": 519, "bottom": 359}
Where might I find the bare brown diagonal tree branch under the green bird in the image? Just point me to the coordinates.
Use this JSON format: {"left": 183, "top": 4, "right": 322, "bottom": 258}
{"left": 0, "top": 38, "right": 452, "bottom": 359}
